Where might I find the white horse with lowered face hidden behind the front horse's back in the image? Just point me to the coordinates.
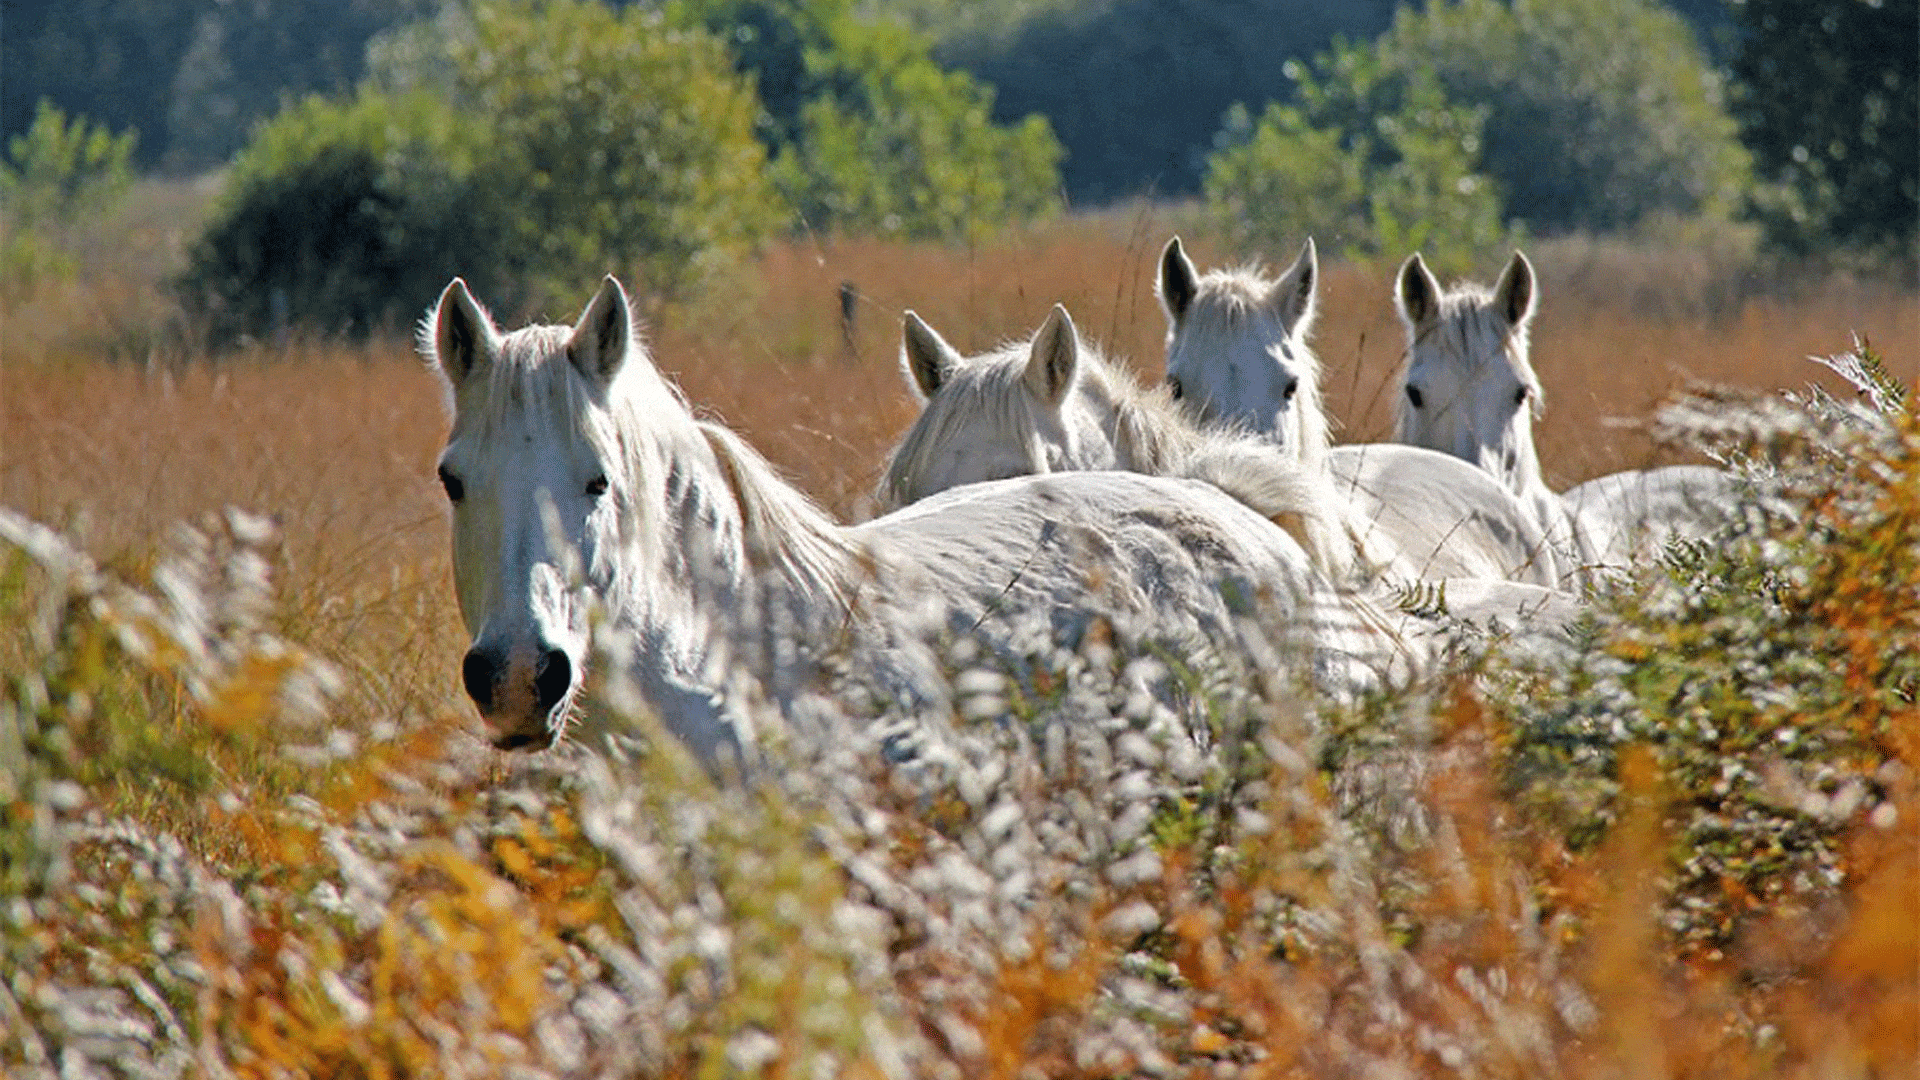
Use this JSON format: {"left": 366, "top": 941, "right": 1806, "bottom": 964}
{"left": 879, "top": 306, "right": 1571, "bottom": 623}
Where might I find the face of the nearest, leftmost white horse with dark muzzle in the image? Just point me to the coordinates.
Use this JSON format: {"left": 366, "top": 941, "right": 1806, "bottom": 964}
{"left": 434, "top": 279, "right": 628, "bottom": 749}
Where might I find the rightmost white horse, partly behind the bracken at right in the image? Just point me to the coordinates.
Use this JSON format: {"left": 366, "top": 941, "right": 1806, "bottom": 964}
{"left": 1394, "top": 252, "right": 1734, "bottom": 569}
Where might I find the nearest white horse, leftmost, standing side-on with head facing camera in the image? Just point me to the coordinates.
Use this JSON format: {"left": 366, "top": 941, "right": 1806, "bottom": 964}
{"left": 420, "top": 279, "right": 1400, "bottom": 761}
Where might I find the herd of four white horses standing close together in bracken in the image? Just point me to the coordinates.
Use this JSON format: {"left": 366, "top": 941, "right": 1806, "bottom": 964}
{"left": 420, "top": 238, "right": 1736, "bottom": 761}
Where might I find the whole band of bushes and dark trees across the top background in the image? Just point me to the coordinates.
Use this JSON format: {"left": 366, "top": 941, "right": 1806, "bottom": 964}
{"left": 0, "top": 0, "right": 1920, "bottom": 336}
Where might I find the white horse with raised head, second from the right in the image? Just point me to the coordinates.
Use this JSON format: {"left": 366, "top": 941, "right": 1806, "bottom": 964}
{"left": 1158, "top": 236, "right": 1563, "bottom": 588}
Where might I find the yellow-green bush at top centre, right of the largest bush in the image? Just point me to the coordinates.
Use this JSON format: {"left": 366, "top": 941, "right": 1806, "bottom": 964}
{"left": 668, "top": 0, "right": 1060, "bottom": 238}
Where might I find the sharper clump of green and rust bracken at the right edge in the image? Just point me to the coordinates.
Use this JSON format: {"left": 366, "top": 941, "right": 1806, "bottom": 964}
{"left": 1511, "top": 346, "right": 1920, "bottom": 949}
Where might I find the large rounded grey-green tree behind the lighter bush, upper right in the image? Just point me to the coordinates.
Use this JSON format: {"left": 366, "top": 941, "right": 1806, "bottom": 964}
{"left": 1379, "top": 0, "right": 1749, "bottom": 231}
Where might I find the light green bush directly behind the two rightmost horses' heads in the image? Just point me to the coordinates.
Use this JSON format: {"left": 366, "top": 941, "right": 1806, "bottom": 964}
{"left": 1204, "top": 42, "right": 1505, "bottom": 273}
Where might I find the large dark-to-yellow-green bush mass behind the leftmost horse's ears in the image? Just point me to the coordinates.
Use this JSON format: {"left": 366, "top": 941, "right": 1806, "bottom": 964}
{"left": 179, "top": 0, "right": 778, "bottom": 344}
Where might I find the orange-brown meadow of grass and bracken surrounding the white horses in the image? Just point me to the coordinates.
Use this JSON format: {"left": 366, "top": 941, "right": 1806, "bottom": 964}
{"left": 0, "top": 192, "right": 1920, "bottom": 1078}
